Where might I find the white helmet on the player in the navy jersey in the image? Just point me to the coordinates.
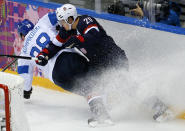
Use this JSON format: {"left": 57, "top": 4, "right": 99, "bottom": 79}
{"left": 56, "top": 4, "right": 78, "bottom": 28}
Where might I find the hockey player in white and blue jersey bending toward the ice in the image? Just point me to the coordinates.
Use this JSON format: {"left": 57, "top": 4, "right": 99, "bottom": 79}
{"left": 18, "top": 12, "right": 57, "bottom": 99}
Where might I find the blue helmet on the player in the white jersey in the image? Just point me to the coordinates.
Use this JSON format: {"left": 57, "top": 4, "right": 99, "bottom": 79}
{"left": 17, "top": 19, "right": 34, "bottom": 36}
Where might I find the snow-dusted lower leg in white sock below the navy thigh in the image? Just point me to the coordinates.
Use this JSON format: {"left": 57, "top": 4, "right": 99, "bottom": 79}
{"left": 74, "top": 68, "right": 113, "bottom": 127}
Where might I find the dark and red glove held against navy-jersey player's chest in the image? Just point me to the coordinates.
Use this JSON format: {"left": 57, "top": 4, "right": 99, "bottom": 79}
{"left": 62, "top": 35, "right": 85, "bottom": 48}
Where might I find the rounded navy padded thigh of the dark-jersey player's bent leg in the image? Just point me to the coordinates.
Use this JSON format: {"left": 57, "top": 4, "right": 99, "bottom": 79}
{"left": 52, "top": 52, "right": 88, "bottom": 91}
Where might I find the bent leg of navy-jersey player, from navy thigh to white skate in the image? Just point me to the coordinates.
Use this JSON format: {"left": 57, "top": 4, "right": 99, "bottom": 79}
{"left": 53, "top": 53, "right": 112, "bottom": 127}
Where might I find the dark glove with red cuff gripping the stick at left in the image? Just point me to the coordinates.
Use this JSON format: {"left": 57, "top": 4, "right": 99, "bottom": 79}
{"left": 35, "top": 48, "right": 49, "bottom": 66}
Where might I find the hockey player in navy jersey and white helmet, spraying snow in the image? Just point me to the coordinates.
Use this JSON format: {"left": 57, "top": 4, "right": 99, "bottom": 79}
{"left": 37, "top": 4, "right": 175, "bottom": 126}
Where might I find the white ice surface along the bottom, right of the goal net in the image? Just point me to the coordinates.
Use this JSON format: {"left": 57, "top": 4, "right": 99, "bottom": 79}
{"left": 25, "top": 87, "right": 185, "bottom": 131}
